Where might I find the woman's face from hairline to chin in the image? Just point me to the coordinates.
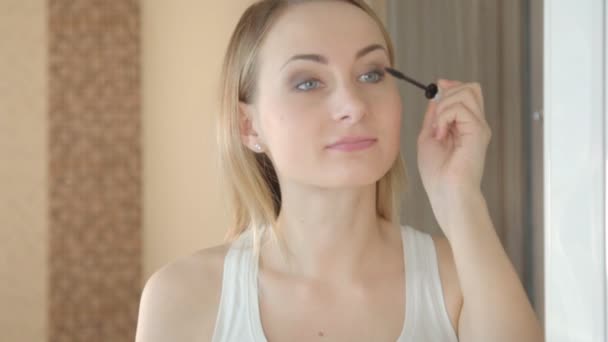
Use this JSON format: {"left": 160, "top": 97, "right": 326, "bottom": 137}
{"left": 245, "top": 1, "right": 401, "bottom": 188}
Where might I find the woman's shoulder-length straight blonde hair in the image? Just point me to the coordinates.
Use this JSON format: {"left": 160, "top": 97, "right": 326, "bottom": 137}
{"left": 217, "top": 0, "right": 407, "bottom": 252}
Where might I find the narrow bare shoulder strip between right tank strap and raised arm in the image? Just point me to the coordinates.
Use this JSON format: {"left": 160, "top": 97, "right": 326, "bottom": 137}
{"left": 431, "top": 234, "right": 462, "bottom": 333}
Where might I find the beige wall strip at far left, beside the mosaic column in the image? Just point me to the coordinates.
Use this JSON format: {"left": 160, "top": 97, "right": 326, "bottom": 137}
{"left": 0, "top": 0, "right": 47, "bottom": 341}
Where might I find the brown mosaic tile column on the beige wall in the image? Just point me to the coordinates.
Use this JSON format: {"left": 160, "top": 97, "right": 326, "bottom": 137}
{"left": 48, "top": 0, "right": 141, "bottom": 342}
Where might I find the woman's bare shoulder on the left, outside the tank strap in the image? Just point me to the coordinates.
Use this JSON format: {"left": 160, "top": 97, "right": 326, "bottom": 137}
{"left": 136, "top": 244, "right": 229, "bottom": 342}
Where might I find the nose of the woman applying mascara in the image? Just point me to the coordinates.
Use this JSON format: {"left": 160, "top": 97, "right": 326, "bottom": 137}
{"left": 332, "top": 84, "right": 368, "bottom": 123}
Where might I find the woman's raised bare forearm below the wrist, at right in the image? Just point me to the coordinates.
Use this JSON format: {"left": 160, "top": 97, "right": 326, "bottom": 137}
{"left": 442, "top": 192, "right": 543, "bottom": 342}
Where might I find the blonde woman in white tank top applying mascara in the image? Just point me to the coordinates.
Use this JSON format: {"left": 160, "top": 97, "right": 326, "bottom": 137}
{"left": 137, "top": 0, "right": 542, "bottom": 342}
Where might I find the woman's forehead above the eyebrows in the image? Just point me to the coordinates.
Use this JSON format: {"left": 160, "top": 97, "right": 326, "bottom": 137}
{"left": 260, "top": 1, "right": 386, "bottom": 62}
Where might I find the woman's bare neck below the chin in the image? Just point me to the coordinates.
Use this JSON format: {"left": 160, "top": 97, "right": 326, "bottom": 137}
{"left": 262, "top": 184, "right": 389, "bottom": 279}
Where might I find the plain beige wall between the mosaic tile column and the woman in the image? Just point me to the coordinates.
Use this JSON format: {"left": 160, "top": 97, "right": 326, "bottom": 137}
{"left": 142, "top": 0, "right": 252, "bottom": 279}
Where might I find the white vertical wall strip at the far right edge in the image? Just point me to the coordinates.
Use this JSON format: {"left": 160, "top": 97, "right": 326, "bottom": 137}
{"left": 544, "top": 0, "right": 608, "bottom": 342}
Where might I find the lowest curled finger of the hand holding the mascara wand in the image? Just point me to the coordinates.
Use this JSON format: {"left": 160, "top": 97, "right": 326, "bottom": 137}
{"left": 435, "top": 102, "right": 483, "bottom": 140}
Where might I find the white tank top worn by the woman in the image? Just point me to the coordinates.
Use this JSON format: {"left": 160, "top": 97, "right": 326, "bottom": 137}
{"left": 212, "top": 226, "right": 458, "bottom": 342}
